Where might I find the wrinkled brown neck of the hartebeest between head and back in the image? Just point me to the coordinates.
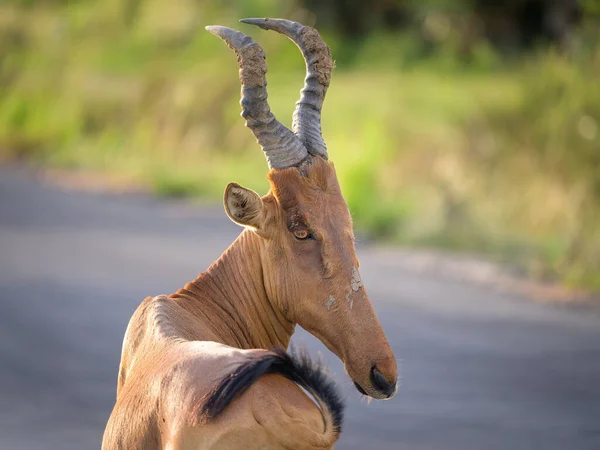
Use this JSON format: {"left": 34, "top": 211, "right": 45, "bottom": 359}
{"left": 171, "top": 230, "right": 294, "bottom": 349}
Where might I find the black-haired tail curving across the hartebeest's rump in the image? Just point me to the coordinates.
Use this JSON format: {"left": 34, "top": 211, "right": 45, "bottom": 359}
{"left": 199, "top": 348, "right": 344, "bottom": 433}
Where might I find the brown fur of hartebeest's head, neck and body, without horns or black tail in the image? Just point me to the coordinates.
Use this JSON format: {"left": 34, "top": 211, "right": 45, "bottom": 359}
{"left": 102, "top": 157, "right": 396, "bottom": 450}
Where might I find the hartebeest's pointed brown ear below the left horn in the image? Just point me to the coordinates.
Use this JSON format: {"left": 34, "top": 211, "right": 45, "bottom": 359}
{"left": 223, "top": 183, "right": 264, "bottom": 230}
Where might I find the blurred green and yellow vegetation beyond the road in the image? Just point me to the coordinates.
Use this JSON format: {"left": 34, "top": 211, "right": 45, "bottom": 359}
{"left": 0, "top": 0, "right": 600, "bottom": 290}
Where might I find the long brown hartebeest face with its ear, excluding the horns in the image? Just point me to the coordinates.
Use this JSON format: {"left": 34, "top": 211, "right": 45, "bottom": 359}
{"left": 226, "top": 157, "right": 397, "bottom": 399}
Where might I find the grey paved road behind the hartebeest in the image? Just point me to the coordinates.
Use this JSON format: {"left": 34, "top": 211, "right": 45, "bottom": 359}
{"left": 0, "top": 167, "right": 600, "bottom": 450}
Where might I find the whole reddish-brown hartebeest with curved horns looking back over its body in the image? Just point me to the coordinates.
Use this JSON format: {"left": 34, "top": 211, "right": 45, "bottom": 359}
{"left": 102, "top": 19, "right": 397, "bottom": 450}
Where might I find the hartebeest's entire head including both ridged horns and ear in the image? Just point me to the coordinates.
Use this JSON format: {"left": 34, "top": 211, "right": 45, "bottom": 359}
{"left": 207, "top": 19, "right": 397, "bottom": 399}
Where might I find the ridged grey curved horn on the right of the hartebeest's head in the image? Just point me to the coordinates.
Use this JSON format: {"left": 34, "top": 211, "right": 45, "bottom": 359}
{"left": 240, "top": 19, "right": 333, "bottom": 159}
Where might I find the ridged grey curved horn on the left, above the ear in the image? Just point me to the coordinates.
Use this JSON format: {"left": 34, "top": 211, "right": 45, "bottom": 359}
{"left": 206, "top": 26, "right": 308, "bottom": 169}
